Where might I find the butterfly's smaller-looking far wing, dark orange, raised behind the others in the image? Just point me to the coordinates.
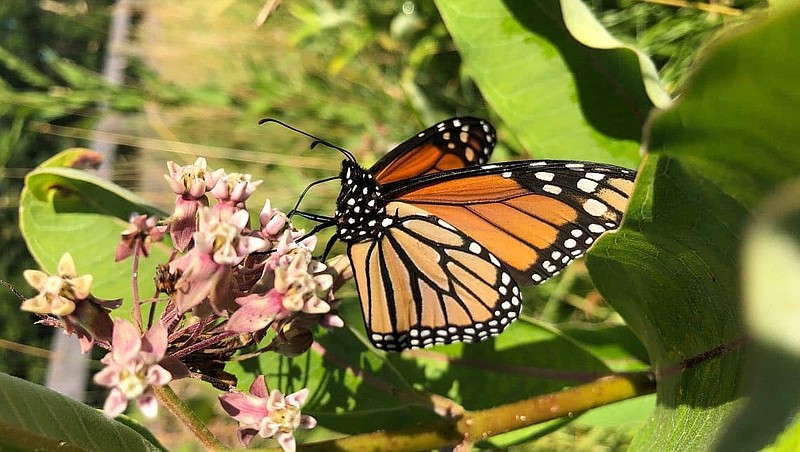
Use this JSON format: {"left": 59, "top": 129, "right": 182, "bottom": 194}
{"left": 370, "top": 117, "right": 497, "bottom": 184}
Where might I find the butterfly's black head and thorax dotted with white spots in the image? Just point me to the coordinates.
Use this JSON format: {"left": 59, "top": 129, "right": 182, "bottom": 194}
{"left": 334, "top": 160, "right": 386, "bottom": 243}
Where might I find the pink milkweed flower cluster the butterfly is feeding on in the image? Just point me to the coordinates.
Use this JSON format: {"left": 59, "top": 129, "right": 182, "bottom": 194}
{"left": 21, "top": 158, "right": 352, "bottom": 450}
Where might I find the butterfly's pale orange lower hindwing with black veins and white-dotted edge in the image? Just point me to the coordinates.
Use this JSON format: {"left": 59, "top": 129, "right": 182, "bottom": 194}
{"left": 348, "top": 202, "right": 520, "bottom": 350}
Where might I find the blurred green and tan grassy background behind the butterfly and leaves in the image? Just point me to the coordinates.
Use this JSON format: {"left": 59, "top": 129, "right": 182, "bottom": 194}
{"left": 0, "top": 0, "right": 760, "bottom": 447}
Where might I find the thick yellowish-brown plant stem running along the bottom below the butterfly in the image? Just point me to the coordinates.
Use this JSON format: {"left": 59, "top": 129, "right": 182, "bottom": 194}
{"left": 303, "top": 373, "right": 656, "bottom": 451}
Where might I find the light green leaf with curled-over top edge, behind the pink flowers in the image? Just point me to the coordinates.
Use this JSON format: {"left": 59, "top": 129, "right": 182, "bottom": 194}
{"left": 19, "top": 150, "right": 171, "bottom": 313}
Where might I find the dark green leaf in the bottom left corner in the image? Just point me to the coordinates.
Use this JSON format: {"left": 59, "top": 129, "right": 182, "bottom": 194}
{"left": 0, "top": 374, "right": 166, "bottom": 451}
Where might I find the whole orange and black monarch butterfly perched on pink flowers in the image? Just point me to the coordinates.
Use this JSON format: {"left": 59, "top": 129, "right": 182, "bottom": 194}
{"left": 276, "top": 117, "right": 636, "bottom": 351}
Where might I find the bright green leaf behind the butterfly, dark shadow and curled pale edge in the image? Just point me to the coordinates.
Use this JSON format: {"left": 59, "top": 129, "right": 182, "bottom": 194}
{"left": 436, "top": 0, "right": 669, "bottom": 167}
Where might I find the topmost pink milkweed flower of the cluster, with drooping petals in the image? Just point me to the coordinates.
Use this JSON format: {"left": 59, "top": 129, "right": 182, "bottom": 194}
{"left": 164, "top": 157, "right": 225, "bottom": 251}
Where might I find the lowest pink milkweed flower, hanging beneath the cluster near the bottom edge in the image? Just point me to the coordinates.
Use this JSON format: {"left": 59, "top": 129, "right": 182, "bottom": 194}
{"left": 219, "top": 375, "right": 317, "bottom": 452}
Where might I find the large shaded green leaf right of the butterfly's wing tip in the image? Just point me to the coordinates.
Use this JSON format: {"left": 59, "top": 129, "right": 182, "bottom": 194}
{"left": 587, "top": 5, "right": 800, "bottom": 450}
